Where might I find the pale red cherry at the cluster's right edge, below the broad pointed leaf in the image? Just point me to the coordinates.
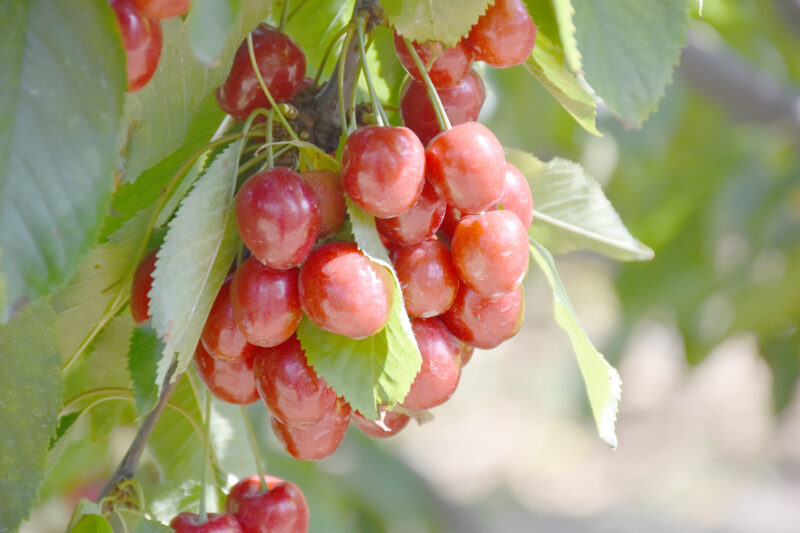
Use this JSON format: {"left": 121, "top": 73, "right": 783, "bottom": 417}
{"left": 452, "top": 211, "right": 529, "bottom": 296}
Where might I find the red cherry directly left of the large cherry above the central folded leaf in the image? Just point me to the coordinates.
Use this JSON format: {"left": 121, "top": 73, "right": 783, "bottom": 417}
{"left": 230, "top": 256, "right": 303, "bottom": 347}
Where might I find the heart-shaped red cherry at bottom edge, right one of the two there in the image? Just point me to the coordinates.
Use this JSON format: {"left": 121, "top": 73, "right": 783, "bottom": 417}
{"left": 225, "top": 476, "right": 308, "bottom": 533}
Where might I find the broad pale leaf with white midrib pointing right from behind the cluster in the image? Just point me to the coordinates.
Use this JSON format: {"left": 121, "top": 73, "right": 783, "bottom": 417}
{"left": 506, "top": 149, "right": 653, "bottom": 261}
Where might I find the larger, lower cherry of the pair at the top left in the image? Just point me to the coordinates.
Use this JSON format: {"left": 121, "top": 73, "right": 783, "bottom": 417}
{"left": 109, "top": 0, "right": 164, "bottom": 92}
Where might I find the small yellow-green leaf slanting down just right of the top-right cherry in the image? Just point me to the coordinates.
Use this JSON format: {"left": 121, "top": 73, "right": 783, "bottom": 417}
{"left": 525, "top": 34, "right": 600, "bottom": 135}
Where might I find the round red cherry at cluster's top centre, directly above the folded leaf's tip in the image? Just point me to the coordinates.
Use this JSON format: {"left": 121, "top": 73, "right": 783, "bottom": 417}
{"left": 342, "top": 126, "right": 425, "bottom": 217}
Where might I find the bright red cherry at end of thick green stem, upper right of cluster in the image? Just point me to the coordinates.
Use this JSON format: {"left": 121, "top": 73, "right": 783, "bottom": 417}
{"left": 425, "top": 122, "right": 506, "bottom": 213}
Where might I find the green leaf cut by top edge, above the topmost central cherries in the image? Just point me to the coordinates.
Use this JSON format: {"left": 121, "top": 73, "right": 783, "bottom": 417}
{"left": 382, "top": 0, "right": 492, "bottom": 46}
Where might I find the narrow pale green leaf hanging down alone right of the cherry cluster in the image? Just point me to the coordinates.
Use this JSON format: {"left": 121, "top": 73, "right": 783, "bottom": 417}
{"left": 530, "top": 239, "right": 622, "bottom": 448}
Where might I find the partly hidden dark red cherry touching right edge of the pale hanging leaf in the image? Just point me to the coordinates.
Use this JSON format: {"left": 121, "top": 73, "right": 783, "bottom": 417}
{"left": 200, "top": 280, "right": 247, "bottom": 363}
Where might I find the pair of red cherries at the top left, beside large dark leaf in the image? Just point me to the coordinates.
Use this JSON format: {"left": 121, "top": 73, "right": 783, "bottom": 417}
{"left": 109, "top": 0, "right": 191, "bottom": 91}
